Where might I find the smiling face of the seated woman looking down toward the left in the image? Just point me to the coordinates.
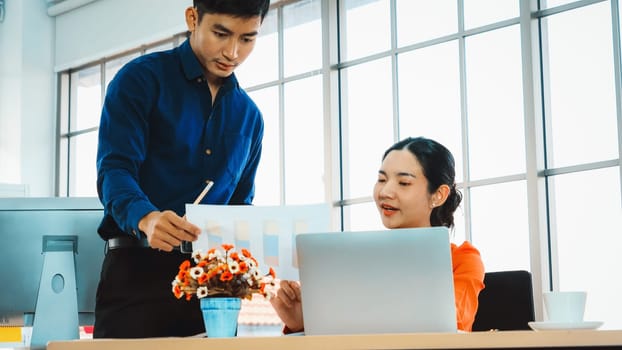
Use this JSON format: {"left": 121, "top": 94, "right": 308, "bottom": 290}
{"left": 374, "top": 150, "right": 440, "bottom": 229}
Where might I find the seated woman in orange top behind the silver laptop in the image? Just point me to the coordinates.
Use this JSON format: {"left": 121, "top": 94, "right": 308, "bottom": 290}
{"left": 271, "top": 137, "right": 484, "bottom": 333}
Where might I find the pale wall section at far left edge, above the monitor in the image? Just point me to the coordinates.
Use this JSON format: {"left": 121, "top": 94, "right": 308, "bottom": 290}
{"left": 0, "top": 0, "right": 56, "bottom": 196}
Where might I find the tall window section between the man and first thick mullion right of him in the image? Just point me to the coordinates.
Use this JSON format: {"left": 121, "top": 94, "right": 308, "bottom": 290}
{"left": 236, "top": 0, "right": 330, "bottom": 205}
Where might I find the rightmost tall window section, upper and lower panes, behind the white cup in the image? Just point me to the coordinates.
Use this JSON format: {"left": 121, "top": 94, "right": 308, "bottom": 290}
{"left": 541, "top": 1, "right": 622, "bottom": 328}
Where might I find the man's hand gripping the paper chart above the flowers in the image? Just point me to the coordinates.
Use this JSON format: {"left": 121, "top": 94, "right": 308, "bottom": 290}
{"left": 138, "top": 210, "right": 201, "bottom": 252}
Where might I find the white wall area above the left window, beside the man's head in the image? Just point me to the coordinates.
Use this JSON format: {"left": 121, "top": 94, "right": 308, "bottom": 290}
{"left": 55, "top": 0, "right": 192, "bottom": 71}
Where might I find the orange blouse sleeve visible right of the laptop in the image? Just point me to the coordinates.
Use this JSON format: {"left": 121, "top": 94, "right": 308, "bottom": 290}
{"left": 451, "top": 242, "right": 484, "bottom": 332}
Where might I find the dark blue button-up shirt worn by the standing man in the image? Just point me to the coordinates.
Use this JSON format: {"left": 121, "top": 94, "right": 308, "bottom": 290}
{"left": 97, "top": 41, "right": 264, "bottom": 238}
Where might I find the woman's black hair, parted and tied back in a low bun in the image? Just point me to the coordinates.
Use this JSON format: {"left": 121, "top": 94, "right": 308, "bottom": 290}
{"left": 382, "top": 137, "right": 462, "bottom": 228}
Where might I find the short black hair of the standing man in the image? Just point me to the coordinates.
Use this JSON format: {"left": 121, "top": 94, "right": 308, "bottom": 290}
{"left": 193, "top": 0, "right": 270, "bottom": 22}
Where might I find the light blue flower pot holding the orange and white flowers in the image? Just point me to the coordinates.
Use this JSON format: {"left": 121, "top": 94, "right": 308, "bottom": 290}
{"left": 201, "top": 297, "right": 242, "bottom": 338}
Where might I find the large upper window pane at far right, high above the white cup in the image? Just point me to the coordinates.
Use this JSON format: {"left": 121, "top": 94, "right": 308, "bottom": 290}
{"left": 542, "top": 2, "right": 619, "bottom": 167}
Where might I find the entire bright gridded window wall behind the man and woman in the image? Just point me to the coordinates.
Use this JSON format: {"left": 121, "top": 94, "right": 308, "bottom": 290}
{"left": 59, "top": 0, "right": 622, "bottom": 328}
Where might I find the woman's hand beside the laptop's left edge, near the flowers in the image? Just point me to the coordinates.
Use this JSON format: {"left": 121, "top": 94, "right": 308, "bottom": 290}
{"left": 270, "top": 280, "right": 304, "bottom": 332}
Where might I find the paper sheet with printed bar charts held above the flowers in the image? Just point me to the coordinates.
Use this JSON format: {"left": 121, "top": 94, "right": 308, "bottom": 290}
{"left": 186, "top": 204, "right": 330, "bottom": 280}
